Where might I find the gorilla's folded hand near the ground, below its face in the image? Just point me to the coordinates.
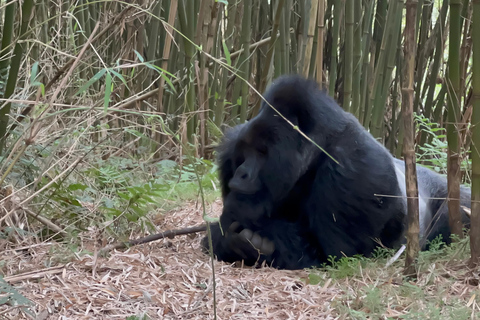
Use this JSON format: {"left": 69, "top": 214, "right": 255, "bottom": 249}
{"left": 225, "top": 221, "right": 275, "bottom": 260}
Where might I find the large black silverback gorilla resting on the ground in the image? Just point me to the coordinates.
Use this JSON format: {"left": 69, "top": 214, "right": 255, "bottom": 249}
{"left": 202, "top": 76, "right": 470, "bottom": 269}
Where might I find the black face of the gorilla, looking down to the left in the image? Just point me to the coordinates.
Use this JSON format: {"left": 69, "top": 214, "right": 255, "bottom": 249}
{"left": 228, "top": 115, "right": 312, "bottom": 202}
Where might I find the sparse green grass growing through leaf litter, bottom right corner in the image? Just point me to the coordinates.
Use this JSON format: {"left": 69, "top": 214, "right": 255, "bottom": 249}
{"left": 308, "top": 239, "right": 474, "bottom": 320}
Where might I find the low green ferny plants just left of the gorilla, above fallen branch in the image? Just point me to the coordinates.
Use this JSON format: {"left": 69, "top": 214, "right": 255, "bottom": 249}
{"left": 44, "top": 154, "right": 218, "bottom": 237}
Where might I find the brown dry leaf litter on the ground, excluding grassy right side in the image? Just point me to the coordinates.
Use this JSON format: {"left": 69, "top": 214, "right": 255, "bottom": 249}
{"left": 0, "top": 202, "right": 341, "bottom": 319}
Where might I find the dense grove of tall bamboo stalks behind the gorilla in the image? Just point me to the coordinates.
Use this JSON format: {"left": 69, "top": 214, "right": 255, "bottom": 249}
{"left": 0, "top": 0, "right": 480, "bottom": 264}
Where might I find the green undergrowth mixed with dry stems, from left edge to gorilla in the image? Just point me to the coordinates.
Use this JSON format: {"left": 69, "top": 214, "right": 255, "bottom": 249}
{"left": 0, "top": 145, "right": 219, "bottom": 240}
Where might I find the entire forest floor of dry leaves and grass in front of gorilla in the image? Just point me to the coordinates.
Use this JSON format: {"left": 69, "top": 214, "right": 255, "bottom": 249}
{"left": 0, "top": 201, "right": 480, "bottom": 320}
